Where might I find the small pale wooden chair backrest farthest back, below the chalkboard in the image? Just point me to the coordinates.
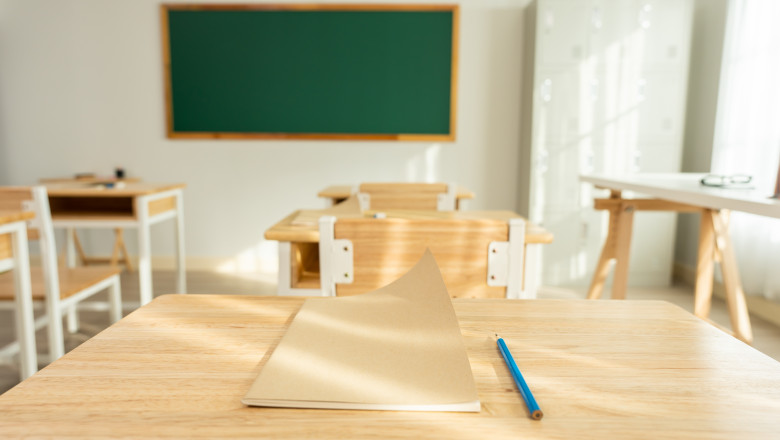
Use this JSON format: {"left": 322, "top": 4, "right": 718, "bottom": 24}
{"left": 358, "top": 183, "right": 457, "bottom": 211}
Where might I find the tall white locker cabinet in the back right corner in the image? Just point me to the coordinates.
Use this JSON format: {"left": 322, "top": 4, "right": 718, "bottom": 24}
{"left": 522, "top": 0, "right": 692, "bottom": 286}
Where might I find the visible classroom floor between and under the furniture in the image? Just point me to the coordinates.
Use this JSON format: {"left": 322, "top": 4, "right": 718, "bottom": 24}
{"left": 0, "top": 271, "right": 780, "bottom": 393}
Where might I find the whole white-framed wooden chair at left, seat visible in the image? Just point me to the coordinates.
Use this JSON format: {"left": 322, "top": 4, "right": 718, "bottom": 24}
{"left": 0, "top": 186, "right": 122, "bottom": 368}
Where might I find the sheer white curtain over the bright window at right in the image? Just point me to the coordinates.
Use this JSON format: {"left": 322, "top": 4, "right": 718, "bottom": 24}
{"left": 712, "top": 0, "right": 780, "bottom": 301}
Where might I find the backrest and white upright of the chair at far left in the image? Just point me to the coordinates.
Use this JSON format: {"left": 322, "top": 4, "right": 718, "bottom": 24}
{"left": 0, "top": 186, "right": 59, "bottom": 298}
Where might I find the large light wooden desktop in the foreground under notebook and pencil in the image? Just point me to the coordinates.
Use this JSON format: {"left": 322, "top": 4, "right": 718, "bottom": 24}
{"left": 0, "top": 295, "right": 780, "bottom": 440}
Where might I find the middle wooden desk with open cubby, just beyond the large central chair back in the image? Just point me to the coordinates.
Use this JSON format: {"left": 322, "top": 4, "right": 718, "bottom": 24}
{"left": 265, "top": 210, "right": 553, "bottom": 297}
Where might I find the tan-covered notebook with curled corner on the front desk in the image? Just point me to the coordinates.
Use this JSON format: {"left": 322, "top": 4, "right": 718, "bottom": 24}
{"left": 242, "top": 252, "right": 480, "bottom": 412}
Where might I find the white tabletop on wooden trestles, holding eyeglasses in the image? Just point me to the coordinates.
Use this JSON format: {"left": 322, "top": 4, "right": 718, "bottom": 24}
{"left": 580, "top": 173, "right": 780, "bottom": 218}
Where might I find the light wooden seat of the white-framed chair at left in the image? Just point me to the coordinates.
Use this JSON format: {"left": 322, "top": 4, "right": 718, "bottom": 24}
{"left": 0, "top": 266, "right": 120, "bottom": 301}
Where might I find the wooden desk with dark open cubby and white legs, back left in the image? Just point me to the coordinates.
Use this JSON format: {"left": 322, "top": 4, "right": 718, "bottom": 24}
{"left": 46, "top": 182, "right": 187, "bottom": 304}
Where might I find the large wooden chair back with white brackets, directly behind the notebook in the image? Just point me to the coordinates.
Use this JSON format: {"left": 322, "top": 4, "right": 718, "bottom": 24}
{"left": 319, "top": 217, "right": 525, "bottom": 298}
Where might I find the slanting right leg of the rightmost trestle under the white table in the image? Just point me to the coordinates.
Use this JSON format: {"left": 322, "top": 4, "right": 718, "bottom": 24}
{"left": 711, "top": 210, "right": 753, "bottom": 344}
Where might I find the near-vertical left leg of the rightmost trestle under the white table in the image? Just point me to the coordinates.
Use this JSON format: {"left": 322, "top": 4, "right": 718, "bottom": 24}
{"left": 693, "top": 209, "right": 717, "bottom": 319}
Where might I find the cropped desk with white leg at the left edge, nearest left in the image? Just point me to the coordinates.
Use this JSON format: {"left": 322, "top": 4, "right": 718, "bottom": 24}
{"left": 0, "top": 207, "right": 38, "bottom": 378}
